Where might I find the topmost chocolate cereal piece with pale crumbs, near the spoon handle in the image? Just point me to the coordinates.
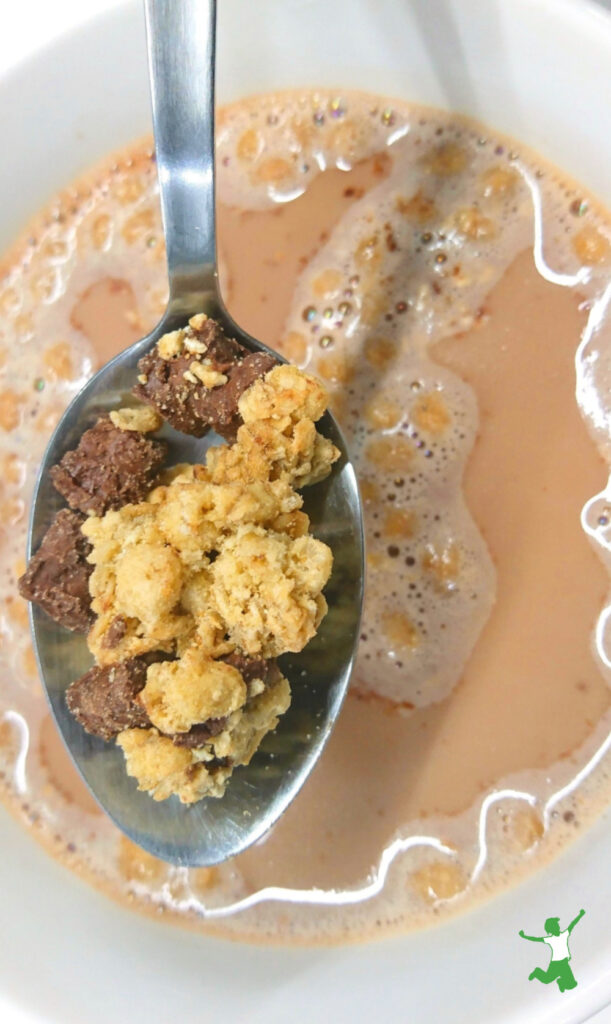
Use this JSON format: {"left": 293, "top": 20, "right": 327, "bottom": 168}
{"left": 133, "top": 314, "right": 276, "bottom": 440}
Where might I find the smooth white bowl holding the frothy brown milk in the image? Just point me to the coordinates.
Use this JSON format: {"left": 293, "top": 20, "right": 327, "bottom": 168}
{"left": 0, "top": 0, "right": 611, "bottom": 1024}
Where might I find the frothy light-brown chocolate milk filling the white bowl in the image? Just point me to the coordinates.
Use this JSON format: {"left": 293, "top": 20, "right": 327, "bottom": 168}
{"left": 0, "top": 93, "right": 611, "bottom": 942}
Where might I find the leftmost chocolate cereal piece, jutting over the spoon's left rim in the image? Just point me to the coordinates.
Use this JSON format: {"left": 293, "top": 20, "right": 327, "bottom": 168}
{"left": 18, "top": 509, "right": 94, "bottom": 633}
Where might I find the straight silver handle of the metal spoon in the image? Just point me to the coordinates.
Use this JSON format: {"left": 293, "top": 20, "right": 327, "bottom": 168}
{"left": 144, "top": 0, "right": 216, "bottom": 315}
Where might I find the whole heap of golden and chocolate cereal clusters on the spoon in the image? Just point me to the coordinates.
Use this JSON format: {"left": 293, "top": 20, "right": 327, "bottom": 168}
{"left": 21, "top": 314, "right": 339, "bottom": 803}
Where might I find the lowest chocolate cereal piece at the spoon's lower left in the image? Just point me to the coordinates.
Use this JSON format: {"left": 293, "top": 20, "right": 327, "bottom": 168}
{"left": 66, "top": 657, "right": 150, "bottom": 739}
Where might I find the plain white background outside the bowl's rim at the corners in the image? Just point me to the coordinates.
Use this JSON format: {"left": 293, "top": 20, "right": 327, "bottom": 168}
{"left": 0, "top": 0, "right": 611, "bottom": 1024}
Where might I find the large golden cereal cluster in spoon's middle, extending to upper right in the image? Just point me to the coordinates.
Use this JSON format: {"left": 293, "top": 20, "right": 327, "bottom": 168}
{"left": 82, "top": 367, "right": 336, "bottom": 666}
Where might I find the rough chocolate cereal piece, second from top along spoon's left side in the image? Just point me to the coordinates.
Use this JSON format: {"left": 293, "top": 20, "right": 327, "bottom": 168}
{"left": 51, "top": 416, "right": 167, "bottom": 516}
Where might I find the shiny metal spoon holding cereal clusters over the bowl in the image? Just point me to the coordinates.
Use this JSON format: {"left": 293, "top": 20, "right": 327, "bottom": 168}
{"left": 28, "top": 0, "right": 363, "bottom": 866}
